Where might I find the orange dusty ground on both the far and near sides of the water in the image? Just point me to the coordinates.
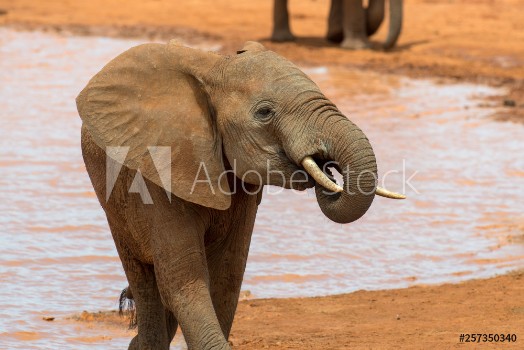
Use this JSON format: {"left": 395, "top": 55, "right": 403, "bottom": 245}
{"left": 0, "top": 0, "right": 524, "bottom": 349}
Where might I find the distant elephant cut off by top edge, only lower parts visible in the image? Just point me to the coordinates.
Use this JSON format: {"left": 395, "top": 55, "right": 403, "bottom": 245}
{"left": 271, "top": 0, "right": 403, "bottom": 50}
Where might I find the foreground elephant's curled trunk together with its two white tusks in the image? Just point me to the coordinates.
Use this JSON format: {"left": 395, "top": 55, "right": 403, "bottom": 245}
{"left": 286, "top": 93, "right": 406, "bottom": 224}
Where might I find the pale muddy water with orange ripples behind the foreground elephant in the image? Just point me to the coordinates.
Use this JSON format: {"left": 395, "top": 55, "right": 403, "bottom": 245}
{"left": 0, "top": 29, "right": 524, "bottom": 349}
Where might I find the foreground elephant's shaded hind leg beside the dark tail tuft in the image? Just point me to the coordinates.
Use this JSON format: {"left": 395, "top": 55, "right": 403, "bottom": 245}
{"left": 108, "top": 217, "right": 177, "bottom": 350}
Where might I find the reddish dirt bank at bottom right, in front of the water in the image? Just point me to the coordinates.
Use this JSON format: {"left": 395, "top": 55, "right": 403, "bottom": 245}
{"left": 73, "top": 272, "right": 524, "bottom": 350}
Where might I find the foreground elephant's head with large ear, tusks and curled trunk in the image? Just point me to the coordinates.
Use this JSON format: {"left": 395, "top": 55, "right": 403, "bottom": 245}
{"left": 77, "top": 42, "right": 404, "bottom": 223}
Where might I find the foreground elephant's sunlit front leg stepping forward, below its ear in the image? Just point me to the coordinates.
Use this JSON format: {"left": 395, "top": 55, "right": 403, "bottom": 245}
{"left": 148, "top": 208, "right": 230, "bottom": 350}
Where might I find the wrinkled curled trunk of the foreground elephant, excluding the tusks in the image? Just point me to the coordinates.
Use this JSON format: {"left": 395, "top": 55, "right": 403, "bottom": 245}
{"left": 306, "top": 116, "right": 377, "bottom": 223}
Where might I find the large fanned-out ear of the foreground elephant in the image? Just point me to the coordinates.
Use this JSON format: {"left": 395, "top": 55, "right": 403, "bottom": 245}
{"left": 76, "top": 43, "right": 231, "bottom": 210}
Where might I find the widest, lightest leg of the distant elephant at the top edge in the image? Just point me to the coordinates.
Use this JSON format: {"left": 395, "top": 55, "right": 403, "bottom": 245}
{"left": 340, "top": 0, "right": 370, "bottom": 50}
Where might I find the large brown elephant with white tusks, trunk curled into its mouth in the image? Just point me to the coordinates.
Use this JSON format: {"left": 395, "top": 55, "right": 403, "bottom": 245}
{"left": 76, "top": 41, "right": 402, "bottom": 349}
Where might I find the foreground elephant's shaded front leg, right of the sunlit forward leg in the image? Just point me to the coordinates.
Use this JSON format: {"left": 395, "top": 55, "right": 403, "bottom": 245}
{"left": 206, "top": 194, "right": 257, "bottom": 339}
